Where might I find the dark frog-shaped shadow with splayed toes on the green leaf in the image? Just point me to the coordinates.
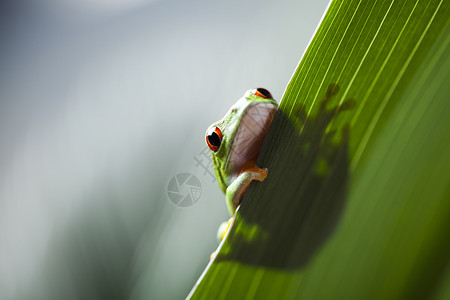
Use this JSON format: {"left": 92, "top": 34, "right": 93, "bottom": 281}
{"left": 215, "top": 84, "right": 354, "bottom": 269}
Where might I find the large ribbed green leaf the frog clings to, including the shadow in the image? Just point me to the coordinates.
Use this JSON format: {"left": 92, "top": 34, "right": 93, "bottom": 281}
{"left": 190, "top": 0, "right": 450, "bottom": 299}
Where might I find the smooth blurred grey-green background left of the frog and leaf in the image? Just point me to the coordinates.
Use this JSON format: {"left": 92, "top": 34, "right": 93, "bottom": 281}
{"left": 0, "top": 0, "right": 328, "bottom": 299}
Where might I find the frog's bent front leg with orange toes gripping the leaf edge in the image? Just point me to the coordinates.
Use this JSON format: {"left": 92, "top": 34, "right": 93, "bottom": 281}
{"left": 226, "top": 166, "right": 268, "bottom": 215}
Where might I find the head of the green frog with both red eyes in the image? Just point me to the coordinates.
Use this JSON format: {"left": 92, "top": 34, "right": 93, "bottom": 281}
{"left": 206, "top": 88, "right": 278, "bottom": 192}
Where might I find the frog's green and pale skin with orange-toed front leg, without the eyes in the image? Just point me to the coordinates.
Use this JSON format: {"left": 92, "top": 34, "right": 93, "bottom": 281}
{"left": 208, "top": 89, "right": 278, "bottom": 215}
